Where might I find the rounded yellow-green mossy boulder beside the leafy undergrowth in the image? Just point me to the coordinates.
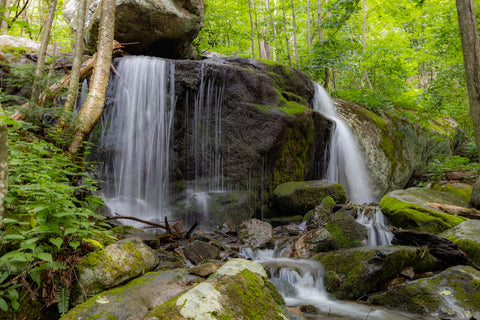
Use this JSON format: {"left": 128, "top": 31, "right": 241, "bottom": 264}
{"left": 73, "top": 238, "right": 159, "bottom": 304}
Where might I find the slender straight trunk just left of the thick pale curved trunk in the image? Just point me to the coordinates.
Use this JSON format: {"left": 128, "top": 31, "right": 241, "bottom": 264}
{"left": 64, "top": 0, "right": 87, "bottom": 112}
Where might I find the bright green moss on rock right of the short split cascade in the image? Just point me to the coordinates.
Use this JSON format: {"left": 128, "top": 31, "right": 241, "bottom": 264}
{"left": 380, "top": 195, "right": 467, "bottom": 234}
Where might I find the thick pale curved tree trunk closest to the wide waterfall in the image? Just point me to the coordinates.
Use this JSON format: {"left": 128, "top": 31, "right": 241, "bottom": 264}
{"left": 68, "top": 0, "right": 115, "bottom": 154}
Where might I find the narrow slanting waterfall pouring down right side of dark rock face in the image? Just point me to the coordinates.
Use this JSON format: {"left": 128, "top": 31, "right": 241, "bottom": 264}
{"left": 313, "top": 83, "right": 375, "bottom": 204}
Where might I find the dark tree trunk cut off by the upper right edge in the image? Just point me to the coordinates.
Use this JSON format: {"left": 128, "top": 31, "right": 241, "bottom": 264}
{"left": 456, "top": 0, "right": 480, "bottom": 156}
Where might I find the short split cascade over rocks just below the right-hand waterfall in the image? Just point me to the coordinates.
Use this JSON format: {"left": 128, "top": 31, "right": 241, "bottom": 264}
{"left": 357, "top": 207, "right": 393, "bottom": 246}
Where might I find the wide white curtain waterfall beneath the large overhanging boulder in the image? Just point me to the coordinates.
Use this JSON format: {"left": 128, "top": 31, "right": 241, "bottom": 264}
{"left": 100, "top": 56, "right": 175, "bottom": 224}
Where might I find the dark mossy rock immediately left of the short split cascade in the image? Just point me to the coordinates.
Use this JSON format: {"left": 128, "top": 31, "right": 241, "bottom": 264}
{"left": 325, "top": 208, "right": 368, "bottom": 249}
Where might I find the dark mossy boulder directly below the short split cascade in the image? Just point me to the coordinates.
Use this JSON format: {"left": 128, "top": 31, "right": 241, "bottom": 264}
{"left": 314, "top": 246, "right": 435, "bottom": 300}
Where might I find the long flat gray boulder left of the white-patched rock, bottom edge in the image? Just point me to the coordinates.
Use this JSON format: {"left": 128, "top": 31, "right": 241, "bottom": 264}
{"left": 62, "top": 269, "right": 201, "bottom": 320}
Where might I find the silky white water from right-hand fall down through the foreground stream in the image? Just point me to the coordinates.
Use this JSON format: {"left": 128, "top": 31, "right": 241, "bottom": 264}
{"left": 242, "top": 84, "right": 404, "bottom": 320}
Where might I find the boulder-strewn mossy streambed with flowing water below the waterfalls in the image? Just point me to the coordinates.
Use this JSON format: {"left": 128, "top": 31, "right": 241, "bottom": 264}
{"left": 54, "top": 183, "right": 480, "bottom": 319}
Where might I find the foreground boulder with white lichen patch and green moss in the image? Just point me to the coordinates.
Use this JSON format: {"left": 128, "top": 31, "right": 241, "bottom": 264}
{"left": 144, "top": 259, "right": 287, "bottom": 320}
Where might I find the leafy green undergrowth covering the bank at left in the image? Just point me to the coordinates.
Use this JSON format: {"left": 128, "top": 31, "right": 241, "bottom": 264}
{"left": 0, "top": 117, "right": 111, "bottom": 317}
